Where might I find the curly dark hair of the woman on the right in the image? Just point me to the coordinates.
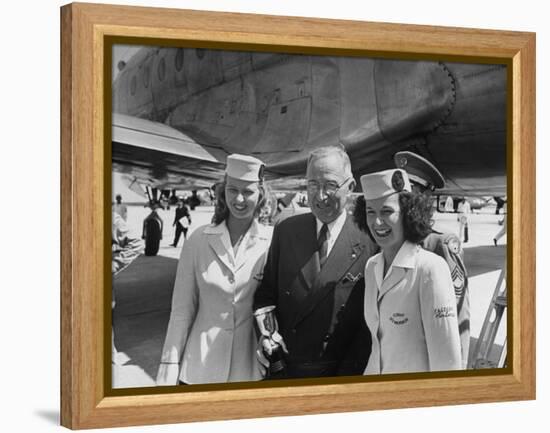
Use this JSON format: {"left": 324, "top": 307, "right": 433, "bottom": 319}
{"left": 353, "top": 191, "right": 433, "bottom": 244}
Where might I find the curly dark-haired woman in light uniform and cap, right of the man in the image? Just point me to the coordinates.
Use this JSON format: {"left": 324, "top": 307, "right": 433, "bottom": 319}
{"left": 361, "top": 169, "right": 462, "bottom": 375}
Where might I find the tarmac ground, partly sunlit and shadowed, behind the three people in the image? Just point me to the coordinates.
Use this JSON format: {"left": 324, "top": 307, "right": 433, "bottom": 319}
{"left": 112, "top": 206, "right": 506, "bottom": 388}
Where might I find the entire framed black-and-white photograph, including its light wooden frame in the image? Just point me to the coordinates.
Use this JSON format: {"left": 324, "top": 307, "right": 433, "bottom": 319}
{"left": 62, "top": 4, "right": 535, "bottom": 428}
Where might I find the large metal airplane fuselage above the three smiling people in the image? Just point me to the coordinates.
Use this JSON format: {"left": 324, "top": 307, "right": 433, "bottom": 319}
{"left": 113, "top": 48, "right": 506, "bottom": 192}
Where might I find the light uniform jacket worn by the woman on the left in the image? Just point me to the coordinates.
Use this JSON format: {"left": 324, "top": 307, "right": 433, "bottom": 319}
{"left": 161, "top": 221, "right": 271, "bottom": 384}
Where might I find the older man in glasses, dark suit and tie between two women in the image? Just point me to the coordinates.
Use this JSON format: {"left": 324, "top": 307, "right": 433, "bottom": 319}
{"left": 254, "top": 146, "right": 377, "bottom": 378}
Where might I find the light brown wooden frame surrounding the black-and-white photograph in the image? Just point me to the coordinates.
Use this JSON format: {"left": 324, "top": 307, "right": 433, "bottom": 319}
{"left": 61, "top": 3, "right": 535, "bottom": 429}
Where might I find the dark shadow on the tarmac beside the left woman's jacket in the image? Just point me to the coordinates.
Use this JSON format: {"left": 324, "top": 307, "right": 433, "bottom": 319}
{"left": 113, "top": 255, "right": 178, "bottom": 379}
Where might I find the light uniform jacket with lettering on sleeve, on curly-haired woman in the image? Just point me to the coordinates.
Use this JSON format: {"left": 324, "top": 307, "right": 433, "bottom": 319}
{"left": 364, "top": 242, "right": 461, "bottom": 374}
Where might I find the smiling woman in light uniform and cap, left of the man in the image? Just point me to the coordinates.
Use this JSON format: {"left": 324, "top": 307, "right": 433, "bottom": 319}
{"left": 157, "top": 154, "right": 271, "bottom": 385}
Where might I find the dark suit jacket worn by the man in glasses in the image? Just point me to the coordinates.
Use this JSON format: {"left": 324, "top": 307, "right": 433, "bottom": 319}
{"left": 254, "top": 213, "right": 377, "bottom": 377}
